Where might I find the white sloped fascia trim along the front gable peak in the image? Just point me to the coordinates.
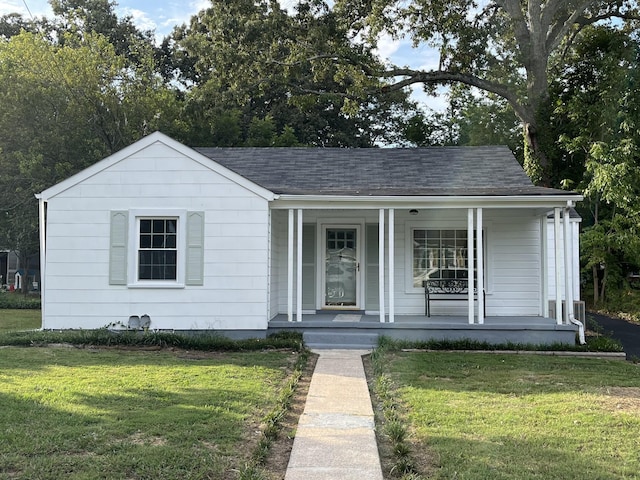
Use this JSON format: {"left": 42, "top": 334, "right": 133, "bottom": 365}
{"left": 36, "top": 132, "right": 274, "bottom": 201}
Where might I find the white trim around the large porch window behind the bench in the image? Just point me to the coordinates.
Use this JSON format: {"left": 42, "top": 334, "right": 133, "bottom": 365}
{"left": 404, "top": 220, "right": 493, "bottom": 295}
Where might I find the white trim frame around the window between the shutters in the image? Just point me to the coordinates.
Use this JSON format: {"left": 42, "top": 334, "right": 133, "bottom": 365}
{"left": 127, "top": 209, "right": 187, "bottom": 288}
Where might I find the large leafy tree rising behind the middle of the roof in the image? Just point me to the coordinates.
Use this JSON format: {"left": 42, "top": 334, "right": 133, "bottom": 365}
{"left": 168, "top": 0, "right": 407, "bottom": 146}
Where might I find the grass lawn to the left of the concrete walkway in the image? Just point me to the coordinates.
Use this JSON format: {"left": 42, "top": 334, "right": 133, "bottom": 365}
{"left": 0, "top": 347, "right": 297, "bottom": 480}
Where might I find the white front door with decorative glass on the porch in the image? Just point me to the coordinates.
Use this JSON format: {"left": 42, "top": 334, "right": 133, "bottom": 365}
{"left": 322, "top": 225, "right": 360, "bottom": 309}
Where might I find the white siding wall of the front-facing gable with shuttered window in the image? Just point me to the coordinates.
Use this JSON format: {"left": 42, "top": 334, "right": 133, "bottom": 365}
{"left": 44, "top": 144, "right": 268, "bottom": 330}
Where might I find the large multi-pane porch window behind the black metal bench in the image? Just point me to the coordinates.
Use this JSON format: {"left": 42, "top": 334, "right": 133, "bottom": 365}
{"left": 412, "top": 228, "right": 477, "bottom": 288}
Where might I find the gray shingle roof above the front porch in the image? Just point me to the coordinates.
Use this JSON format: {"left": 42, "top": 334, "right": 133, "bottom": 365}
{"left": 195, "top": 146, "right": 568, "bottom": 196}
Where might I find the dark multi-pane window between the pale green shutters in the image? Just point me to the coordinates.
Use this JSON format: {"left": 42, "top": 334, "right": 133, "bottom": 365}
{"left": 138, "top": 218, "right": 178, "bottom": 280}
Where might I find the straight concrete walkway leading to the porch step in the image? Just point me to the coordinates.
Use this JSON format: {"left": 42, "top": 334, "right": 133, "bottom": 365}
{"left": 285, "top": 350, "right": 382, "bottom": 480}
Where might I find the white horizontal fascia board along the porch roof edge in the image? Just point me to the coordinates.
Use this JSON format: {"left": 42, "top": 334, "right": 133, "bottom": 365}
{"left": 271, "top": 193, "right": 583, "bottom": 210}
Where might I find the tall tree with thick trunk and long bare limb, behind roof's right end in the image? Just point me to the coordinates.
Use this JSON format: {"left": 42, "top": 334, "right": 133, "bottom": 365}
{"left": 335, "top": 0, "right": 639, "bottom": 185}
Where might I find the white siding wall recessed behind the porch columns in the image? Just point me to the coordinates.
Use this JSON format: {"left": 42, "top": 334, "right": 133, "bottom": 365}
{"left": 274, "top": 209, "right": 542, "bottom": 316}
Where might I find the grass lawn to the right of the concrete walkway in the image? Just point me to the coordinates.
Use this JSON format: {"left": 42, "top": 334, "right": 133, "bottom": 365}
{"left": 379, "top": 352, "right": 640, "bottom": 480}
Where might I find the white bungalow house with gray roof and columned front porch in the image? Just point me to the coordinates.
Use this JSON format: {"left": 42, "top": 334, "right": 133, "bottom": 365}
{"left": 37, "top": 133, "right": 582, "bottom": 344}
